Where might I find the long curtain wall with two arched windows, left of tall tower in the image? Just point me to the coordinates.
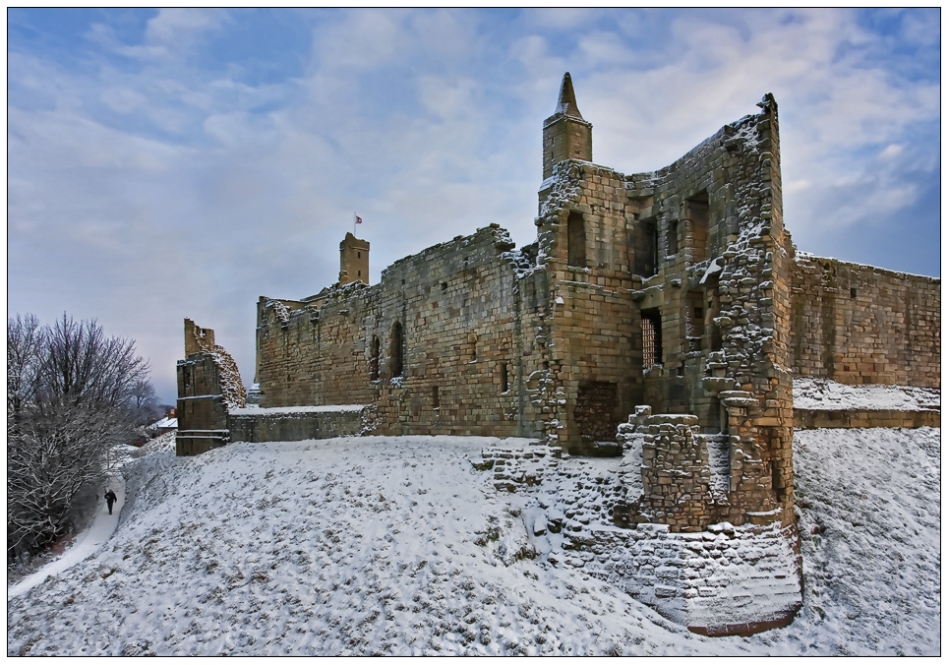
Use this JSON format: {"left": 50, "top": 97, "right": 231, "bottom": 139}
{"left": 257, "top": 225, "right": 547, "bottom": 436}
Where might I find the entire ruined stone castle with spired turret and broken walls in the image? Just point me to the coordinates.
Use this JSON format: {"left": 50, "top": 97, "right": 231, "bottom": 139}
{"left": 178, "top": 74, "right": 940, "bottom": 634}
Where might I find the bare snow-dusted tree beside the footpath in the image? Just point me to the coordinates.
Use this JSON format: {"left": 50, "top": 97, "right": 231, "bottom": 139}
{"left": 7, "top": 314, "right": 154, "bottom": 556}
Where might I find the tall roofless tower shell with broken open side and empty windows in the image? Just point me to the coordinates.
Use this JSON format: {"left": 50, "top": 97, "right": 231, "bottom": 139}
{"left": 537, "top": 96, "right": 793, "bottom": 529}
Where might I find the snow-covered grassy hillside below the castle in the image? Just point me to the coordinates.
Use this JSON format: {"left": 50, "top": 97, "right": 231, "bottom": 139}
{"left": 7, "top": 429, "right": 940, "bottom": 655}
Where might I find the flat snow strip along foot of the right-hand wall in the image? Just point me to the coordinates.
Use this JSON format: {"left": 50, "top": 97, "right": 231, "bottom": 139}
{"left": 794, "top": 378, "right": 940, "bottom": 411}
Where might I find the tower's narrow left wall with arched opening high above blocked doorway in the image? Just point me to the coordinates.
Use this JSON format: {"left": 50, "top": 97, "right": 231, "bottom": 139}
{"left": 536, "top": 161, "right": 642, "bottom": 454}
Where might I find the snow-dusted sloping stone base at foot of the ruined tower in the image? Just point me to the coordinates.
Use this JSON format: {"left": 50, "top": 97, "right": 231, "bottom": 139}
{"left": 575, "top": 523, "right": 802, "bottom": 635}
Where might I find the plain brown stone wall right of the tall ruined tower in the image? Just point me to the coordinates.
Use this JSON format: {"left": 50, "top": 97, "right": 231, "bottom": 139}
{"left": 791, "top": 254, "right": 941, "bottom": 388}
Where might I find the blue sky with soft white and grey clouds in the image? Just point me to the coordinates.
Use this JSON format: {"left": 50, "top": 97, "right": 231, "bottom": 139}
{"left": 7, "top": 9, "right": 940, "bottom": 403}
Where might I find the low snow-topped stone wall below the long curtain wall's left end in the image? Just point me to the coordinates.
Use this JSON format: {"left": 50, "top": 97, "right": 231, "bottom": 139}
{"left": 227, "top": 405, "right": 372, "bottom": 443}
